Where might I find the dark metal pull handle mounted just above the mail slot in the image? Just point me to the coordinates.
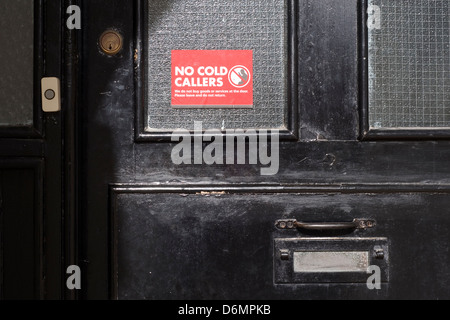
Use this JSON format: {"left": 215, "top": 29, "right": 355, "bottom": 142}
{"left": 275, "top": 219, "right": 376, "bottom": 231}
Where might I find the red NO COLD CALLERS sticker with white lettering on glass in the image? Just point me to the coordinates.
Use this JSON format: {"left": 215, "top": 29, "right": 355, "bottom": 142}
{"left": 172, "top": 50, "right": 253, "bottom": 108}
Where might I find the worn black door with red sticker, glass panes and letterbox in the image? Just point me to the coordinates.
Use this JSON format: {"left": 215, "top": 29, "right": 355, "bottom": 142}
{"left": 74, "top": 0, "right": 450, "bottom": 299}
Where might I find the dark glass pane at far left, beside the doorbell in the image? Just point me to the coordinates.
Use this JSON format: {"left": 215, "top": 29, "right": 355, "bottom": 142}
{"left": 0, "top": 0, "right": 34, "bottom": 126}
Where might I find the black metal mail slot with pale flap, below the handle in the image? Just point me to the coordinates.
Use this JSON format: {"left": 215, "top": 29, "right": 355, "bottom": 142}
{"left": 274, "top": 238, "right": 389, "bottom": 284}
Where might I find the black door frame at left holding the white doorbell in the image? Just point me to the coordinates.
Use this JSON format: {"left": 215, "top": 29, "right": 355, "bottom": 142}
{"left": 0, "top": 0, "right": 80, "bottom": 300}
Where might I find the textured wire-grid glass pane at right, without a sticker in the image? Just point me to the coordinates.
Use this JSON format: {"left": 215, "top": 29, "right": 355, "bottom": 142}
{"left": 369, "top": 0, "right": 450, "bottom": 128}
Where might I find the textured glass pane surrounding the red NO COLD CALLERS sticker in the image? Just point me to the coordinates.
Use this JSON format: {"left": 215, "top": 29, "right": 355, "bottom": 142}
{"left": 147, "top": 0, "right": 287, "bottom": 131}
